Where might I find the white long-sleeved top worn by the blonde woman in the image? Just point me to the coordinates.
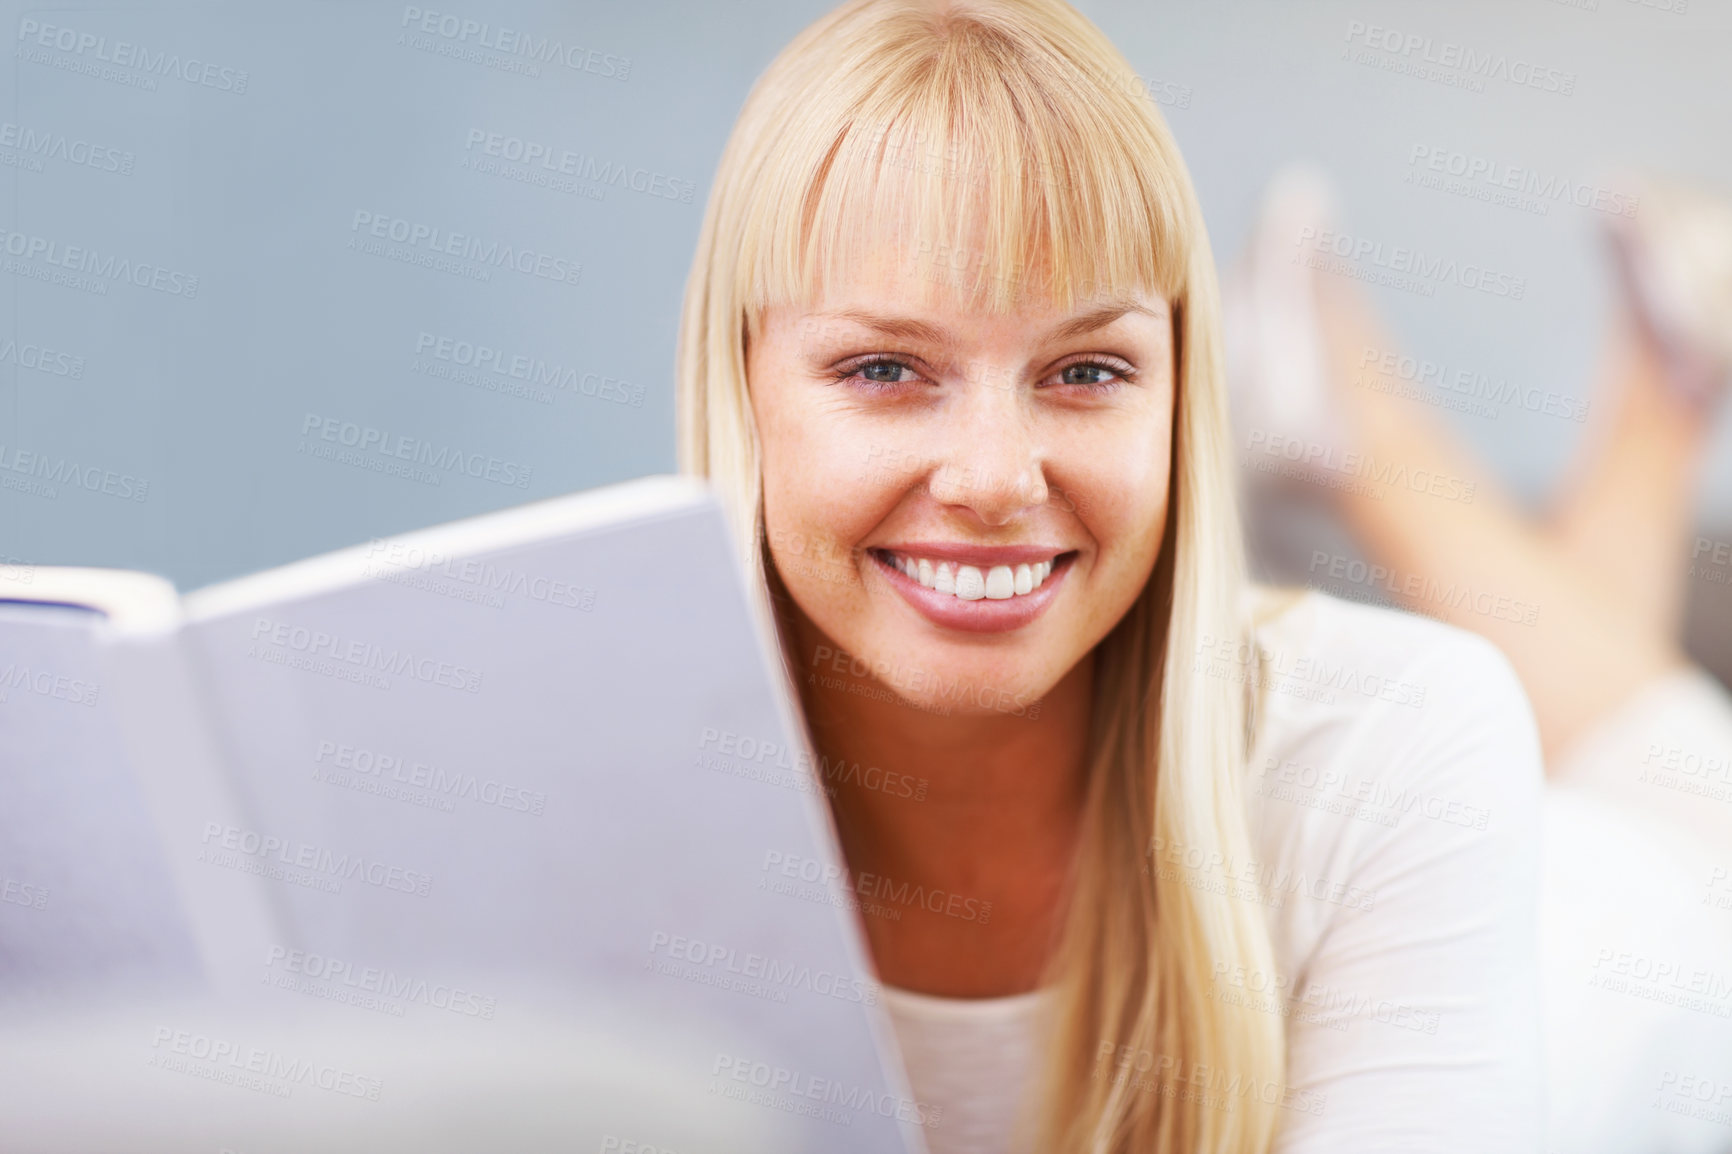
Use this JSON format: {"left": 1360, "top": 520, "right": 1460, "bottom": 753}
{"left": 885, "top": 593, "right": 1543, "bottom": 1154}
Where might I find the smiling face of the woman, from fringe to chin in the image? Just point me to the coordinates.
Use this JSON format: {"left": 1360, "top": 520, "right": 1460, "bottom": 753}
{"left": 746, "top": 256, "right": 1174, "bottom": 714}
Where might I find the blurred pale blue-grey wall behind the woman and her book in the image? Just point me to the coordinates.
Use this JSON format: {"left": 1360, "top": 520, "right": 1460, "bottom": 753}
{"left": 0, "top": 0, "right": 1732, "bottom": 676}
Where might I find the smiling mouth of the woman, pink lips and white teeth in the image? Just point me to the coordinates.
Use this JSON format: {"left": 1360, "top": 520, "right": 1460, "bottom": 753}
{"left": 868, "top": 544, "right": 1076, "bottom": 632}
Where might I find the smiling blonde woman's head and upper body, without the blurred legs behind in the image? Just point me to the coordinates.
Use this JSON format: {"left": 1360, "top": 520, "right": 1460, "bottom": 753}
{"left": 679, "top": 0, "right": 1540, "bottom": 1154}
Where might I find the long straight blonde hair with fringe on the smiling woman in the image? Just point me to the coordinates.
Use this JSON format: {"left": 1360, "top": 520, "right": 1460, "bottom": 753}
{"left": 677, "top": 0, "right": 1285, "bottom": 1154}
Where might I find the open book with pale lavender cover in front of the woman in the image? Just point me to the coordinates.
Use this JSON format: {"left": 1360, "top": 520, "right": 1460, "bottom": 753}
{"left": 0, "top": 477, "right": 939, "bottom": 1151}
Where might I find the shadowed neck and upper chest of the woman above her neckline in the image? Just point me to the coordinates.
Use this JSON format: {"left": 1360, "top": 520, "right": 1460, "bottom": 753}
{"left": 790, "top": 610, "right": 1095, "bottom": 998}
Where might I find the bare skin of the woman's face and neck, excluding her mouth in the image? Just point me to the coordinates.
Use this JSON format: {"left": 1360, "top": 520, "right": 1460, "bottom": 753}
{"left": 746, "top": 256, "right": 1174, "bottom": 996}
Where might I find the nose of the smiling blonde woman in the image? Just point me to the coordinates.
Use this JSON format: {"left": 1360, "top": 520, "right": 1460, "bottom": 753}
{"left": 927, "top": 366, "right": 1050, "bottom": 527}
